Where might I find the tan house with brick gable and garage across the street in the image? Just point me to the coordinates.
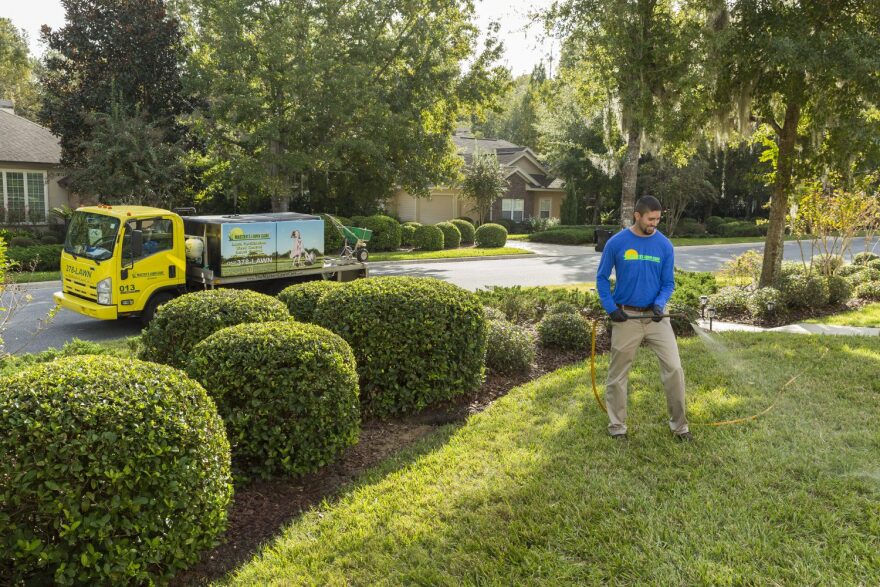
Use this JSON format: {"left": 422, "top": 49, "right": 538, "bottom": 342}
{"left": 388, "top": 130, "right": 565, "bottom": 224}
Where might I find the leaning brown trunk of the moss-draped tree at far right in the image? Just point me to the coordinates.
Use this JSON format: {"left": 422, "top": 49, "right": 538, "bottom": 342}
{"left": 759, "top": 102, "right": 801, "bottom": 287}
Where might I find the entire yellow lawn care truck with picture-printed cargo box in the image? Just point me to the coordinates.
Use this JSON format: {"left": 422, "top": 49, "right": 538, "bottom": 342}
{"left": 55, "top": 205, "right": 368, "bottom": 323}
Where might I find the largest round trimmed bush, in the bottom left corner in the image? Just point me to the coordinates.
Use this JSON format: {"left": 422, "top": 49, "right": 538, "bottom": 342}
{"left": 0, "top": 356, "right": 232, "bottom": 585}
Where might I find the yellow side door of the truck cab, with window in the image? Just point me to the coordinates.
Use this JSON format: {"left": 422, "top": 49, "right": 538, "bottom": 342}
{"left": 119, "top": 217, "right": 186, "bottom": 312}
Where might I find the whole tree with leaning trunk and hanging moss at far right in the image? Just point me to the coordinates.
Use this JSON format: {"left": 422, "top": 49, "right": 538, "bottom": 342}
{"left": 714, "top": 0, "right": 880, "bottom": 286}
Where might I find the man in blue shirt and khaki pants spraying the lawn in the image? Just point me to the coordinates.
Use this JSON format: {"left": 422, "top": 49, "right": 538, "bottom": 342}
{"left": 596, "top": 196, "right": 693, "bottom": 442}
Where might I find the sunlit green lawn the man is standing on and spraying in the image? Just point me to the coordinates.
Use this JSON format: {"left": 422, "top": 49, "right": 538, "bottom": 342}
{"left": 223, "top": 333, "right": 880, "bottom": 585}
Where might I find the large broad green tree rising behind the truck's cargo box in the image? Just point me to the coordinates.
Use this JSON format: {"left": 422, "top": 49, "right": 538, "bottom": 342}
{"left": 187, "top": 0, "right": 506, "bottom": 214}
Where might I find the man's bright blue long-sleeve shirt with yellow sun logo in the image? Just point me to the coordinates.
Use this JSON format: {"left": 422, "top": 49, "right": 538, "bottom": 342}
{"left": 596, "top": 229, "right": 675, "bottom": 314}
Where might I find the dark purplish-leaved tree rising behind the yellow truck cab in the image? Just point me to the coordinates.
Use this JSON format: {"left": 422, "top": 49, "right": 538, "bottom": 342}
{"left": 40, "top": 0, "right": 189, "bottom": 168}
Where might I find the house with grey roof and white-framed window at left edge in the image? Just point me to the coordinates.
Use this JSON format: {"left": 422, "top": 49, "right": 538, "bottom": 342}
{"left": 0, "top": 100, "right": 69, "bottom": 225}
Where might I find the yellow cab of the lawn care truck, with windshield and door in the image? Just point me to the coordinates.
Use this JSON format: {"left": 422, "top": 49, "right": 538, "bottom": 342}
{"left": 55, "top": 205, "right": 186, "bottom": 320}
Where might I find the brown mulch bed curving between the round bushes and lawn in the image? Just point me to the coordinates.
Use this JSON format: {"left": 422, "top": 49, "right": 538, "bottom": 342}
{"left": 171, "top": 333, "right": 610, "bottom": 585}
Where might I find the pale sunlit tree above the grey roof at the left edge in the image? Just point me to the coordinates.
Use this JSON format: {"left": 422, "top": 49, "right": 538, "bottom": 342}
{"left": 0, "top": 18, "right": 40, "bottom": 120}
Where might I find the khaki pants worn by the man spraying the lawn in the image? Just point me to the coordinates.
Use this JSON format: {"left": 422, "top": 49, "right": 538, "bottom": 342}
{"left": 605, "top": 318, "right": 688, "bottom": 434}
